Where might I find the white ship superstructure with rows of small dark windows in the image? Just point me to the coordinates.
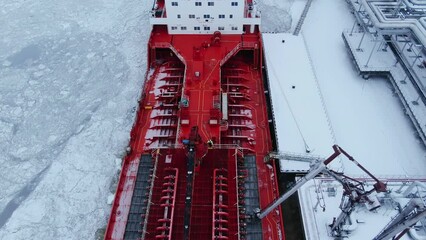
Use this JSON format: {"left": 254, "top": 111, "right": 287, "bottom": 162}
{"left": 150, "top": 0, "right": 260, "bottom": 34}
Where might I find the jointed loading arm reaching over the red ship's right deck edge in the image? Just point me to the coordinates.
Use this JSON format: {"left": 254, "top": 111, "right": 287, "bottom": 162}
{"left": 255, "top": 145, "right": 386, "bottom": 219}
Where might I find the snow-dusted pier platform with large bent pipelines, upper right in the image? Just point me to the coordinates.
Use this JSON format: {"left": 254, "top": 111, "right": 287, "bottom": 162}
{"left": 342, "top": 0, "right": 426, "bottom": 145}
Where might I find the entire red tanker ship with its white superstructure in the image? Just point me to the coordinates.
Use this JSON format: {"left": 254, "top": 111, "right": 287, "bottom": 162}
{"left": 105, "top": 0, "right": 285, "bottom": 239}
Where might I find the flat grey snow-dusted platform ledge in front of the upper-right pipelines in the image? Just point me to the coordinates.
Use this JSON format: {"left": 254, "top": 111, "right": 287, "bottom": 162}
{"left": 342, "top": 32, "right": 426, "bottom": 145}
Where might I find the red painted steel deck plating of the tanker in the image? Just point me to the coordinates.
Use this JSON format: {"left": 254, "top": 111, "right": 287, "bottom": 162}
{"left": 105, "top": 23, "right": 285, "bottom": 239}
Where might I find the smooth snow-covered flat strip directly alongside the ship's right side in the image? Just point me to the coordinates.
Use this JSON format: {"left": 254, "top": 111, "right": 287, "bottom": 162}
{"left": 263, "top": 33, "right": 334, "bottom": 172}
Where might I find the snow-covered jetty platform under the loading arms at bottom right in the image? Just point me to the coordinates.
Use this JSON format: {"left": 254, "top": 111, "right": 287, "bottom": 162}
{"left": 298, "top": 177, "right": 426, "bottom": 240}
